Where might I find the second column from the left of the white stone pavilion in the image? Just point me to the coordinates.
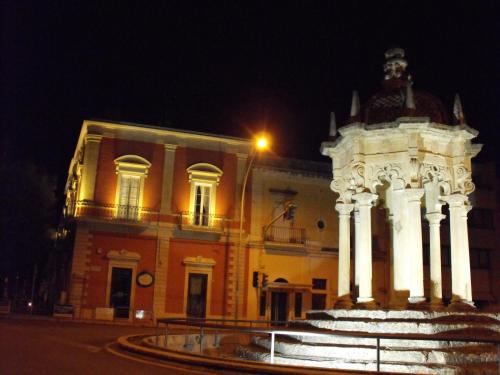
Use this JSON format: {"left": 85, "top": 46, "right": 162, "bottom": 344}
{"left": 352, "top": 193, "right": 378, "bottom": 304}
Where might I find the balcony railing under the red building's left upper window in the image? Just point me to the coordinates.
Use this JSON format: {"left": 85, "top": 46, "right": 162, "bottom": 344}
{"left": 73, "top": 201, "right": 158, "bottom": 223}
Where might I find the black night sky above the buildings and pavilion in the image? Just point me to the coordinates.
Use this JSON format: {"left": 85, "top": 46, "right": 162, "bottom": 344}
{"left": 1, "top": 0, "right": 500, "bottom": 188}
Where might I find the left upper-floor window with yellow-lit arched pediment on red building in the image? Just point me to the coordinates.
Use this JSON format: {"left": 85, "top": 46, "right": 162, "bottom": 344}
{"left": 115, "top": 155, "right": 151, "bottom": 220}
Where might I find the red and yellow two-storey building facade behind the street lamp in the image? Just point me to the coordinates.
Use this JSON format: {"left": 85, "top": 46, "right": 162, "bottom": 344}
{"left": 60, "top": 121, "right": 337, "bottom": 320}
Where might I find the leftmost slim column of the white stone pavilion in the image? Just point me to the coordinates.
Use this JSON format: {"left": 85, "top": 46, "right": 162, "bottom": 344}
{"left": 335, "top": 203, "right": 354, "bottom": 308}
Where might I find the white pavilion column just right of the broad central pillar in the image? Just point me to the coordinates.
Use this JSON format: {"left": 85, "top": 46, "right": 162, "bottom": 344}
{"left": 405, "top": 189, "right": 425, "bottom": 303}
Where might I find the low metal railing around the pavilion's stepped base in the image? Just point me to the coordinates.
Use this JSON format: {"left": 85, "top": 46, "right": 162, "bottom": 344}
{"left": 155, "top": 318, "right": 500, "bottom": 371}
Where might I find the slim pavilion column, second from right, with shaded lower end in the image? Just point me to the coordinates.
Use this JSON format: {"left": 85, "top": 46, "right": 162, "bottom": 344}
{"left": 425, "top": 212, "right": 445, "bottom": 307}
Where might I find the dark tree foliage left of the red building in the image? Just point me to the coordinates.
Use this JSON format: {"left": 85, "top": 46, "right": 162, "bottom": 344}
{"left": 0, "top": 162, "right": 56, "bottom": 280}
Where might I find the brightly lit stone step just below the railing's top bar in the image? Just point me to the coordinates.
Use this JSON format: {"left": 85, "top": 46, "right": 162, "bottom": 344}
{"left": 252, "top": 337, "right": 497, "bottom": 365}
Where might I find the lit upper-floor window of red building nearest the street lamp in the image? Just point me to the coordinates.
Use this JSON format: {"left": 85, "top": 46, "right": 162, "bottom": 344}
{"left": 187, "top": 163, "right": 222, "bottom": 227}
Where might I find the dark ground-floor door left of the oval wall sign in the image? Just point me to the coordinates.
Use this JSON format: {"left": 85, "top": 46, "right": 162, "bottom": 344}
{"left": 109, "top": 267, "right": 132, "bottom": 318}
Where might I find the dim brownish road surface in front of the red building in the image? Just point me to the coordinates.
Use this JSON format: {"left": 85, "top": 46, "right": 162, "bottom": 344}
{"left": 0, "top": 316, "right": 241, "bottom": 375}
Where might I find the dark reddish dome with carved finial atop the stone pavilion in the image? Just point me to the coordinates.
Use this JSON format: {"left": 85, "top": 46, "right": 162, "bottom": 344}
{"left": 351, "top": 48, "right": 450, "bottom": 124}
